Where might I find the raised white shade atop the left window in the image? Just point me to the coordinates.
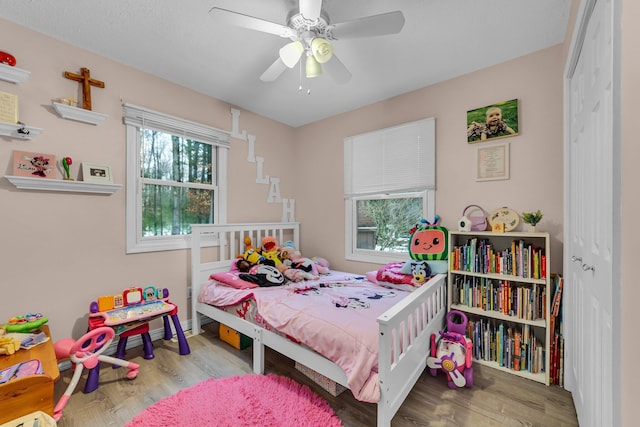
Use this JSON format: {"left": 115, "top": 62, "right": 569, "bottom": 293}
{"left": 123, "top": 104, "right": 230, "bottom": 148}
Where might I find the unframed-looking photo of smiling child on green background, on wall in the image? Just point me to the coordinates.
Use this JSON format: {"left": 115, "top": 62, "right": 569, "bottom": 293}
{"left": 467, "top": 99, "right": 518, "bottom": 144}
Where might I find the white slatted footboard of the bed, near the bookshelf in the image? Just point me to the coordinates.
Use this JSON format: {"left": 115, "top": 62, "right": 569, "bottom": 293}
{"left": 378, "top": 274, "right": 447, "bottom": 427}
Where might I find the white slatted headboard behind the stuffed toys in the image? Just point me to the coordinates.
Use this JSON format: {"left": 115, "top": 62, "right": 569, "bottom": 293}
{"left": 191, "top": 222, "right": 300, "bottom": 292}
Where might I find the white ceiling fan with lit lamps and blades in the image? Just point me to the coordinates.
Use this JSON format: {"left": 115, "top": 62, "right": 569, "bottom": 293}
{"left": 209, "top": 0, "right": 404, "bottom": 84}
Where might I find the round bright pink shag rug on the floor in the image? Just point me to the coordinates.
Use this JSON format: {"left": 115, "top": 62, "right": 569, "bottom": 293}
{"left": 125, "top": 374, "right": 342, "bottom": 427}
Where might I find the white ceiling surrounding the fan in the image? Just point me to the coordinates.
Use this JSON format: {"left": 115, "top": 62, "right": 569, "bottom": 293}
{"left": 0, "top": 0, "right": 571, "bottom": 127}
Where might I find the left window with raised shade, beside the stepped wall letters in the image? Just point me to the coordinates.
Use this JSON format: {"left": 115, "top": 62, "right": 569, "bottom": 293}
{"left": 124, "top": 104, "right": 229, "bottom": 253}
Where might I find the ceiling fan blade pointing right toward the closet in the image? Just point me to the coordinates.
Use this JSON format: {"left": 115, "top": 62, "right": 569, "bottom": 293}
{"left": 329, "top": 10, "right": 404, "bottom": 39}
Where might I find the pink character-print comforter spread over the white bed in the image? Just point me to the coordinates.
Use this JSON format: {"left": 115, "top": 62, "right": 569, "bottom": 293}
{"left": 198, "top": 272, "right": 408, "bottom": 402}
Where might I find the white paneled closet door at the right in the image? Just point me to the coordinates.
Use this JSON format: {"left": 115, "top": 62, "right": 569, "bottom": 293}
{"left": 564, "top": 0, "right": 614, "bottom": 427}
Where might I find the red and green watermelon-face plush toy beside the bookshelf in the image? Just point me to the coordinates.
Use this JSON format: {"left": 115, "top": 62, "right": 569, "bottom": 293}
{"left": 409, "top": 215, "right": 449, "bottom": 274}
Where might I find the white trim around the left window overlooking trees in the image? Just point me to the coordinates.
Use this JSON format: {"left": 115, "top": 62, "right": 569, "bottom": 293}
{"left": 124, "top": 104, "right": 230, "bottom": 254}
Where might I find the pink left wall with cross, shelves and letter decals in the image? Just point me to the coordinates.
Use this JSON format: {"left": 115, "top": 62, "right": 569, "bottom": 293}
{"left": 0, "top": 20, "right": 295, "bottom": 338}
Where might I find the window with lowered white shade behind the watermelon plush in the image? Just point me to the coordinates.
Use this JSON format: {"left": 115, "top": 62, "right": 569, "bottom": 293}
{"left": 344, "top": 118, "right": 435, "bottom": 263}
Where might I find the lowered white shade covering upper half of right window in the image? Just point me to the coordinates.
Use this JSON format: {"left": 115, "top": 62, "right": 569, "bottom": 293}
{"left": 344, "top": 118, "right": 436, "bottom": 198}
